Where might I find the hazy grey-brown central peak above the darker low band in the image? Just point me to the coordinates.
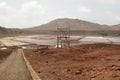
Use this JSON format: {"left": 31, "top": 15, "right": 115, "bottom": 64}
{"left": 30, "top": 18, "right": 116, "bottom": 31}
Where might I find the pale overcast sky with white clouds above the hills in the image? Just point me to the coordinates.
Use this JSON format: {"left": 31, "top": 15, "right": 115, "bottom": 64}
{"left": 0, "top": 0, "right": 120, "bottom": 28}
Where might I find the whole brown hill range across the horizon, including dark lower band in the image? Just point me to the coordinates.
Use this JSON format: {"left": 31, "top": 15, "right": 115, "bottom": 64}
{"left": 0, "top": 18, "right": 120, "bottom": 37}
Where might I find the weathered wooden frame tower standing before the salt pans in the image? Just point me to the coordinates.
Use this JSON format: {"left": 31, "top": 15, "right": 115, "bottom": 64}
{"left": 56, "top": 27, "right": 70, "bottom": 48}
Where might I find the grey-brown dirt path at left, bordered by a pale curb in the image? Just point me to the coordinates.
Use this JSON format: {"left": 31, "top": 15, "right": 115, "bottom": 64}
{"left": 0, "top": 49, "right": 32, "bottom": 80}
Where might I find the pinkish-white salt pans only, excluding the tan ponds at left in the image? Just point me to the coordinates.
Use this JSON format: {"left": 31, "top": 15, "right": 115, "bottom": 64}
{"left": 14, "top": 35, "right": 120, "bottom": 45}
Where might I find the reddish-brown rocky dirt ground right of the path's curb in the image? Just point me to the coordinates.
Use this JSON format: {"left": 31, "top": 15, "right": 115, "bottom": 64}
{"left": 25, "top": 44, "right": 120, "bottom": 80}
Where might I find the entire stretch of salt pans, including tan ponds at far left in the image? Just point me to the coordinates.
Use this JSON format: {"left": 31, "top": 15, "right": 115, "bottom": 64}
{"left": 0, "top": 35, "right": 120, "bottom": 46}
